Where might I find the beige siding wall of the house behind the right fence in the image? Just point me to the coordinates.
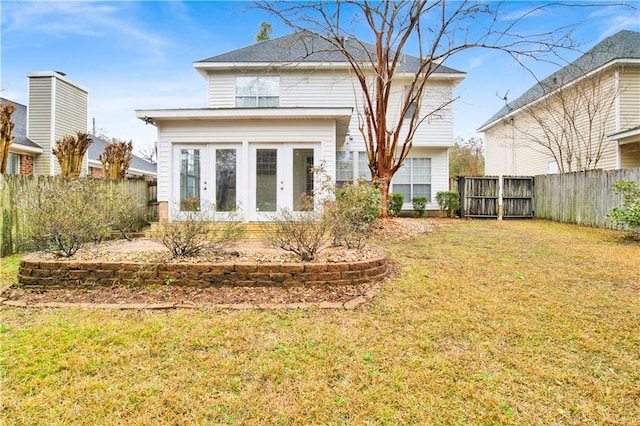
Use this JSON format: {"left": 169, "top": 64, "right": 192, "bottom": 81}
{"left": 485, "top": 66, "right": 626, "bottom": 175}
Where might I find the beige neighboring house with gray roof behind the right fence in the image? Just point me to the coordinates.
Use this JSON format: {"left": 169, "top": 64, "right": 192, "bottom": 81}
{"left": 479, "top": 31, "right": 640, "bottom": 176}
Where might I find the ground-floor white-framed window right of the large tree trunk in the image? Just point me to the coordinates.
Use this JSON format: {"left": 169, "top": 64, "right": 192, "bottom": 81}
{"left": 391, "top": 158, "right": 431, "bottom": 204}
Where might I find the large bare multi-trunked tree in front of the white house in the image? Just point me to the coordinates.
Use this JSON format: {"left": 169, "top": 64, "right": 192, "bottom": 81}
{"left": 257, "top": 0, "right": 600, "bottom": 217}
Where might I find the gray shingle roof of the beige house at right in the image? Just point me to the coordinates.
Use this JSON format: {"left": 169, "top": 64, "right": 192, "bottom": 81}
{"left": 480, "top": 31, "right": 640, "bottom": 129}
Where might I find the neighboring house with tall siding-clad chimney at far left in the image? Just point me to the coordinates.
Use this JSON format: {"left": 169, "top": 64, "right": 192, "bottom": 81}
{"left": 0, "top": 71, "right": 156, "bottom": 180}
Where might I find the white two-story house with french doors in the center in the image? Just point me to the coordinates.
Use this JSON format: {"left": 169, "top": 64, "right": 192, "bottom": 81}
{"left": 136, "top": 32, "right": 465, "bottom": 221}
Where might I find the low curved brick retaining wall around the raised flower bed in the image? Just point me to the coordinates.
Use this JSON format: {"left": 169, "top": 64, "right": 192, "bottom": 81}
{"left": 18, "top": 250, "right": 388, "bottom": 289}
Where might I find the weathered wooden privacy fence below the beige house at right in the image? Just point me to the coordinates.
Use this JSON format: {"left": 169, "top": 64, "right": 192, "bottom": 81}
{"left": 534, "top": 168, "right": 640, "bottom": 228}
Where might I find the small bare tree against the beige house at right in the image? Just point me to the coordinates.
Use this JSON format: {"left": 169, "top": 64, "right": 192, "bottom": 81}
{"left": 510, "top": 62, "right": 621, "bottom": 173}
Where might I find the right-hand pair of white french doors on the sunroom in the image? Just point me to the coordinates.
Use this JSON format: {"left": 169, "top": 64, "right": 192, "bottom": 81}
{"left": 248, "top": 144, "right": 318, "bottom": 221}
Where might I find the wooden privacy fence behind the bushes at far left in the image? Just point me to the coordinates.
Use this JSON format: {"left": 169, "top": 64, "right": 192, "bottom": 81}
{"left": 0, "top": 175, "right": 157, "bottom": 256}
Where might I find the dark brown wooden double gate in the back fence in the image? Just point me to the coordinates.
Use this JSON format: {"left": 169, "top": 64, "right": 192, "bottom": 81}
{"left": 458, "top": 176, "right": 533, "bottom": 218}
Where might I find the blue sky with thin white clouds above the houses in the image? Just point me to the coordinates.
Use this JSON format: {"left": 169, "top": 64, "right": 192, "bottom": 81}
{"left": 0, "top": 0, "right": 640, "bottom": 153}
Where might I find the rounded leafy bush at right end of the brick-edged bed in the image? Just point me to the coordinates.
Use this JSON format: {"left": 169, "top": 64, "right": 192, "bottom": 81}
{"left": 325, "top": 180, "right": 382, "bottom": 248}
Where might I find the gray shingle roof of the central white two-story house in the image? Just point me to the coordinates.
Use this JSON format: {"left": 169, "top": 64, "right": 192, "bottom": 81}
{"left": 197, "top": 31, "right": 462, "bottom": 74}
